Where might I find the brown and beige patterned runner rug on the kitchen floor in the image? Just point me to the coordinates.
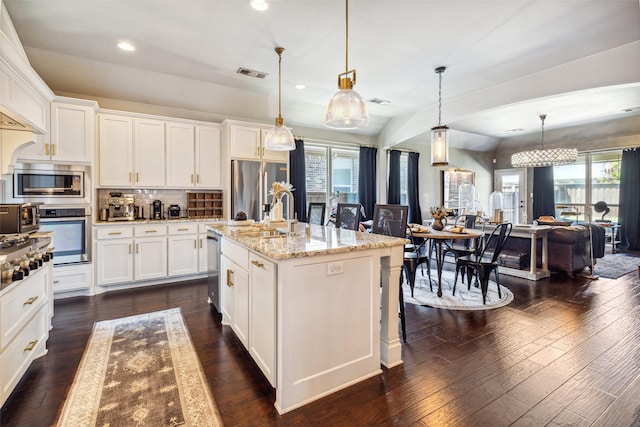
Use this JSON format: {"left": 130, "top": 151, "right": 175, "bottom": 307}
{"left": 58, "top": 308, "right": 222, "bottom": 427}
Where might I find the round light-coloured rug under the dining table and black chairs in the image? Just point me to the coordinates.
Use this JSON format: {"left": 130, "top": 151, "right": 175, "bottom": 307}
{"left": 402, "top": 270, "right": 513, "bottom": 310}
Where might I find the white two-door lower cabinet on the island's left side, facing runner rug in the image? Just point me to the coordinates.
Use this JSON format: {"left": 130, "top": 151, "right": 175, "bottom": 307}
{"left": 220, "top": 239, "right": 277, "bottom": 387}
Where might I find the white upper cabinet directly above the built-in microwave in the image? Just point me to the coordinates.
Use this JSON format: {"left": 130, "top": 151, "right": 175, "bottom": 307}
{"left": 18, "top": 98, "right": 98, "bottom": 165}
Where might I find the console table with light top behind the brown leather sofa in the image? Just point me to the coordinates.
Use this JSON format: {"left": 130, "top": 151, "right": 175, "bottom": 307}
{"left": 485, "top": 224, "right": 551, "bottom": 280}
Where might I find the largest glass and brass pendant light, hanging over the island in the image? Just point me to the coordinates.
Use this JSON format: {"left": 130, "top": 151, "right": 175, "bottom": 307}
{"left": 324, "top": 0, "right": 369, "bottom": 129}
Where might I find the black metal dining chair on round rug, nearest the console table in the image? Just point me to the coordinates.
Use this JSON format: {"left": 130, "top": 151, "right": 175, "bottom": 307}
{"left": 453, "top": 222, "right": 513, "bottom": 304}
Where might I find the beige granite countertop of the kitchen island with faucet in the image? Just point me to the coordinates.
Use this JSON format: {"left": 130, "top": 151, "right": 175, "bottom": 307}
{"left": 207, "top": 223, "right": 408, "bottom": 260}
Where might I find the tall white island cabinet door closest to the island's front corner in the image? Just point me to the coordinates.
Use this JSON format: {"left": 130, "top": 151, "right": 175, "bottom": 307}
{"left": 249, "top": 254, "right": 276, "bottom": 387}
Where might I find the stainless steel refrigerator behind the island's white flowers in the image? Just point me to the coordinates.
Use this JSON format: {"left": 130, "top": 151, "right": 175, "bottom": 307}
{"left": 231, "top": 160, "right": 289, "bottom": 221}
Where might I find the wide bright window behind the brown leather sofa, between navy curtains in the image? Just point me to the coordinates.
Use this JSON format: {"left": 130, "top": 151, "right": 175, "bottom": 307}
{"left": 553, "top": 150, "right": 622, "bottom": 222}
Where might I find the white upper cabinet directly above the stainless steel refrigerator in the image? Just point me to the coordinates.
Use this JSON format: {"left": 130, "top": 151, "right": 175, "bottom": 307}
{"left": 227, "top": 122, "right": 289, "bottom": 162}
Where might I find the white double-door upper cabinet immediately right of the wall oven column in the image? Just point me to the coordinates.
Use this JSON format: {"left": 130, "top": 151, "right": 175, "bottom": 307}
{"left": 98, "top": 114, "right": 165, "bottom": 187}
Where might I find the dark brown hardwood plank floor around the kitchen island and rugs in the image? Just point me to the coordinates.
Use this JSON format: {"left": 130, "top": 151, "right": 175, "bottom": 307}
{"left": 0, "top": 266, "right": 640, "bottom": 426}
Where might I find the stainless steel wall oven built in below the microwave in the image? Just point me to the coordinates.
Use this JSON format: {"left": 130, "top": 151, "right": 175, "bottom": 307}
{"left": 40, "top": 205, "right": 91, "bottom": 266}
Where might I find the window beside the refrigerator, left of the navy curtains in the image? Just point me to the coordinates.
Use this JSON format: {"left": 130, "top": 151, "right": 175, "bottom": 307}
{"left": 304, "top": 142, "right": 360, "bottom": 211}
